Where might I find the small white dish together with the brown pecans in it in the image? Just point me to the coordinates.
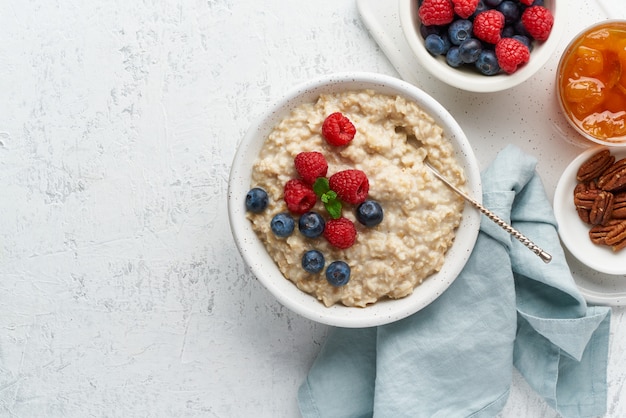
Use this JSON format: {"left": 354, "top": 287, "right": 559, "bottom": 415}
{"left": 554, "top": 146, "right": 626, "bottom": 280}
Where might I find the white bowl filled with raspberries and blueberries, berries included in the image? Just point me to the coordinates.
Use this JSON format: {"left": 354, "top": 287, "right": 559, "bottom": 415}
{"left": 398, "top": 0, "right": 567, "bottom": 93}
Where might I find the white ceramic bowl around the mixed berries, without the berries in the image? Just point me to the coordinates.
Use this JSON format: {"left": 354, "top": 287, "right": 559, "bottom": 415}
{"left": 398, "top": 0, "right": 571, "bottom": 93}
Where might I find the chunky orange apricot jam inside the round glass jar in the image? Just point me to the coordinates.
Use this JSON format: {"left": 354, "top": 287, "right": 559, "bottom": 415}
{"left": 557, "top": 21, "right": 626, "bottom": 143}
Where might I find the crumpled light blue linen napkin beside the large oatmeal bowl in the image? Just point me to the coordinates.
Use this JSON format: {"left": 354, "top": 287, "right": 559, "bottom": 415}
{"left": 298, "top": 146, "right": 611, "bottom": 418}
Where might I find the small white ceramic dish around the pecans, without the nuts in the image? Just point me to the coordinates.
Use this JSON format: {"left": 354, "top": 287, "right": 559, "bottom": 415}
{"left": 553, "top": 146, "right": 626, "bottom": 275}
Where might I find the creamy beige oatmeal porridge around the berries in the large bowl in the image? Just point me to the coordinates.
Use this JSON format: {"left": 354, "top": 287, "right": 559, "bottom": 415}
{"left": 247, "top": 90, "right": 465, "bottom": 307}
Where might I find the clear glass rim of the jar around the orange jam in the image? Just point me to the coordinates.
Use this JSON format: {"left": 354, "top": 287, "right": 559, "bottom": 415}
{"left": 554, "top": 19, "right": 626, "bottom": 148}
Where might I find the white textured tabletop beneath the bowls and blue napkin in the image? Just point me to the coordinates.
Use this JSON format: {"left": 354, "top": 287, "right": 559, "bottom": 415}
{"left": 0, "top": 0, "right": 626, "bottom": 417}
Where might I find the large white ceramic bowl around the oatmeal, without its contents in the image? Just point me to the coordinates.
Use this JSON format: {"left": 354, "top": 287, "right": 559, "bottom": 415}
{"left": 228, "top": 73, "right": 482, "bottom": 328}
